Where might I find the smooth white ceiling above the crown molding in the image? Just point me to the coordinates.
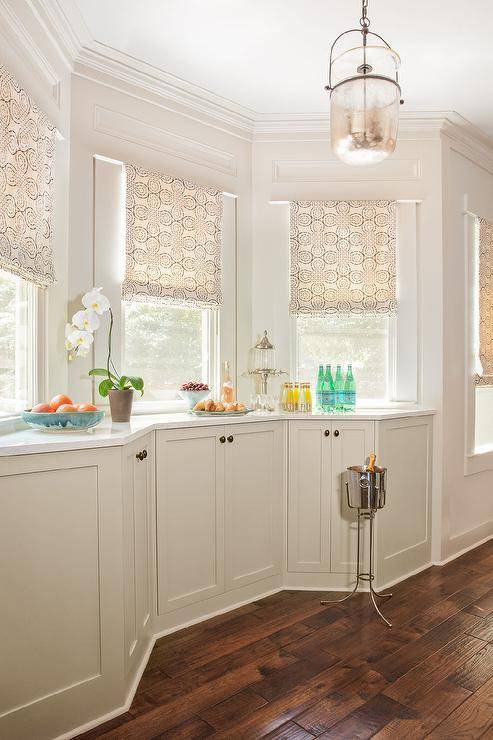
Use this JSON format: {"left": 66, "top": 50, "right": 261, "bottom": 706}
{"left": 71, "top": 0, "right": 493, "bottom": 136}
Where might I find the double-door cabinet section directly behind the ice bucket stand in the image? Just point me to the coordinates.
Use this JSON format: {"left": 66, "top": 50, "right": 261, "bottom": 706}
{"left": 288, "top": 417, "right": 375, "bottom": 573}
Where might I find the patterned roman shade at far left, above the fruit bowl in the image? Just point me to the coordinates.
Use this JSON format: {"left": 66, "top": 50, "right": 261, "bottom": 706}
{"left": 0, "top": 65, "right": 56, "bottom": 288}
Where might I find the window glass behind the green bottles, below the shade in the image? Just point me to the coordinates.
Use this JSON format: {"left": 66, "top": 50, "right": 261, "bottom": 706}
{"left": 296, "top": 316, "right": 389, "bottom": 400}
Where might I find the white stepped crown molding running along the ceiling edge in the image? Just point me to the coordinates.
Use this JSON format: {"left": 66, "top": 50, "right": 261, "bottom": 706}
{"left": 10, "top": 0, "right": 493, "bottom": 159}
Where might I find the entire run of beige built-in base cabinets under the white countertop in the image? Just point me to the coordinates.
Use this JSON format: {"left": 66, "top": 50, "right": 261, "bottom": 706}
{"left": 0, "top": 415, "right": 432, "bottom": 740}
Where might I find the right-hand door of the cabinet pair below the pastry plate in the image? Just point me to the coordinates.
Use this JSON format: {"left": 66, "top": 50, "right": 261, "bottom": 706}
{"left": 225, "top": 421, "right": 283, "bottom": 588}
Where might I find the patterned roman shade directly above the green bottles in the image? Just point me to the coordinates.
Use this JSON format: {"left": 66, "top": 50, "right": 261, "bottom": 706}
{"left": 290, "top": 200, "right": 396, "bottom": 316}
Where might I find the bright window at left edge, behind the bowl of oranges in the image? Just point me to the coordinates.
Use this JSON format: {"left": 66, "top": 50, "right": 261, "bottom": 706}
{"left": 0, "top": 270, "right": 36, "bottom": 416}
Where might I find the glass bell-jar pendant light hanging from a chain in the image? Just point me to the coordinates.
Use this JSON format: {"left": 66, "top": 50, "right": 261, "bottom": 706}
{"left": 325, "top": 0, "right": 404, "bottom": 165}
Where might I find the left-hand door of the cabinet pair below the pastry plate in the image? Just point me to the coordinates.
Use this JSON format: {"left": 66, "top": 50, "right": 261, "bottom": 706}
{"left": 156, "top": 427, "right": 226, "bottom": 614}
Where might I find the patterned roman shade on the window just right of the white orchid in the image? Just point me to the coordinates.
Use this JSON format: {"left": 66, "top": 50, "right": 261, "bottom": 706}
{"left": 122, "top": 165, "right": 223, "bottom": 308}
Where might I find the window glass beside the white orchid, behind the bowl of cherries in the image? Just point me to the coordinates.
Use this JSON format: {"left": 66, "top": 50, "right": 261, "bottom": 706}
{"left": 122, "top": 302, "right": 209, "bottom": 401}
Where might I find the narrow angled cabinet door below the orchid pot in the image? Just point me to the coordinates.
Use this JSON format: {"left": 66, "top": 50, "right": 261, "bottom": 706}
{"left": 123, "top": 434, "right": 154, "bottom": 675}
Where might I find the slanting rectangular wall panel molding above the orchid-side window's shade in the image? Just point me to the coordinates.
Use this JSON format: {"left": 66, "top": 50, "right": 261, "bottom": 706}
{"left": 93, "top": 105, "right": 237, "bottom": 176}
